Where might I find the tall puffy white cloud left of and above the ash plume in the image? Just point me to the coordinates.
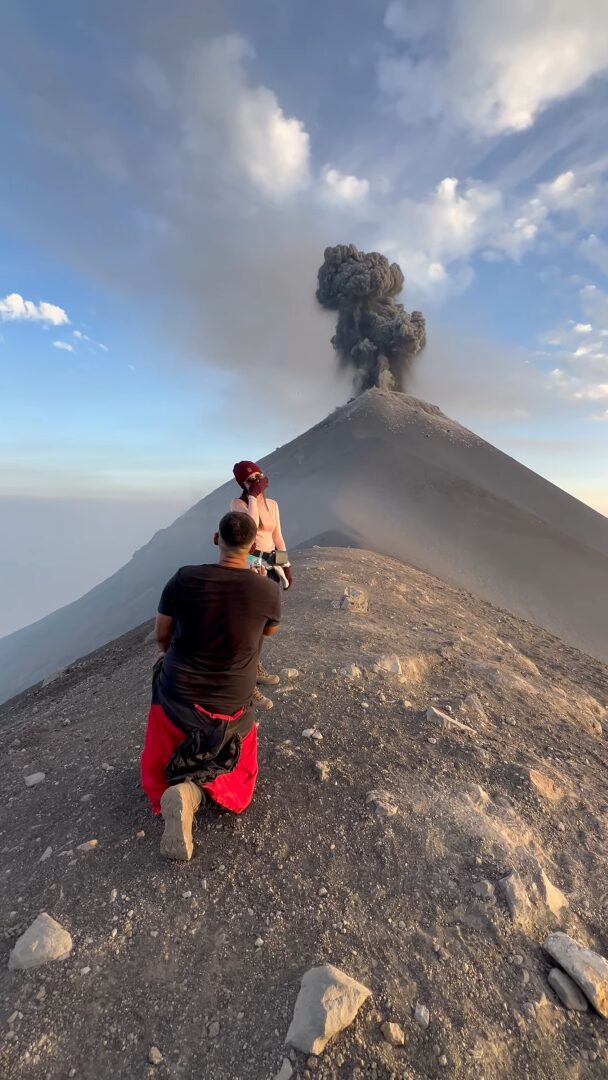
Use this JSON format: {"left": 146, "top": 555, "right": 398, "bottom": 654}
{"left": 185, "top": 35, "right": 310, "bottom": 198}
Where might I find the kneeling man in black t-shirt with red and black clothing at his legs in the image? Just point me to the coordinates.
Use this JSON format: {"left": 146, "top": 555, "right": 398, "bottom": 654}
{"left": 141, "top": 513, "right": 281, "bottom": 861}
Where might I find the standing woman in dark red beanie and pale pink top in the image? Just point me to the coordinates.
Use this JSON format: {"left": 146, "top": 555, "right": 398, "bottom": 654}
{"left": 230, "top": 461, "right": 292, "bottom": 708}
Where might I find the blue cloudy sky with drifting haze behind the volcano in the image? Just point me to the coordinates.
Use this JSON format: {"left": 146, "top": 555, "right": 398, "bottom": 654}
{"left": 0, "top": 0, "right": 608, "bottom": 635}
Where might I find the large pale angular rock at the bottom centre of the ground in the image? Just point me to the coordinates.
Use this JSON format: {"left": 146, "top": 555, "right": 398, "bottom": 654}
{"left": 285, "top": 963, "right": 371, "bottom": 1054}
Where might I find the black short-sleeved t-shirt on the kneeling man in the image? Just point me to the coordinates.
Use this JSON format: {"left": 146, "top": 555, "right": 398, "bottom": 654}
{"left": 159, "top": 565, "right": 281, "bottom": 715}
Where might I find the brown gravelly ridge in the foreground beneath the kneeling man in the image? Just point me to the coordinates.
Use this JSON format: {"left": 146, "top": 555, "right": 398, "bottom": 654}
{"left": 0, "top": 549, "right": 608, "bottom": 1080}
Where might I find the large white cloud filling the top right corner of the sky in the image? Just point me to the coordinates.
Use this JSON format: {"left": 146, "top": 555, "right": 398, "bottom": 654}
{"left": 378, "top": 0, "right": 608, "bottom": 136}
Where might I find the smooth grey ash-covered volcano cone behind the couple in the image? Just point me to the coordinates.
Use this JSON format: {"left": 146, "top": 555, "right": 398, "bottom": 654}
{"left": 0, "top": 390, "right": 608, "bottom": 700}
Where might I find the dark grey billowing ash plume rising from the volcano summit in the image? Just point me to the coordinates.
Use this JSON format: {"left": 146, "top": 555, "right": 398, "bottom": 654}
{"left": 316, "top": 244, "right": 425, "bottom": 393}
